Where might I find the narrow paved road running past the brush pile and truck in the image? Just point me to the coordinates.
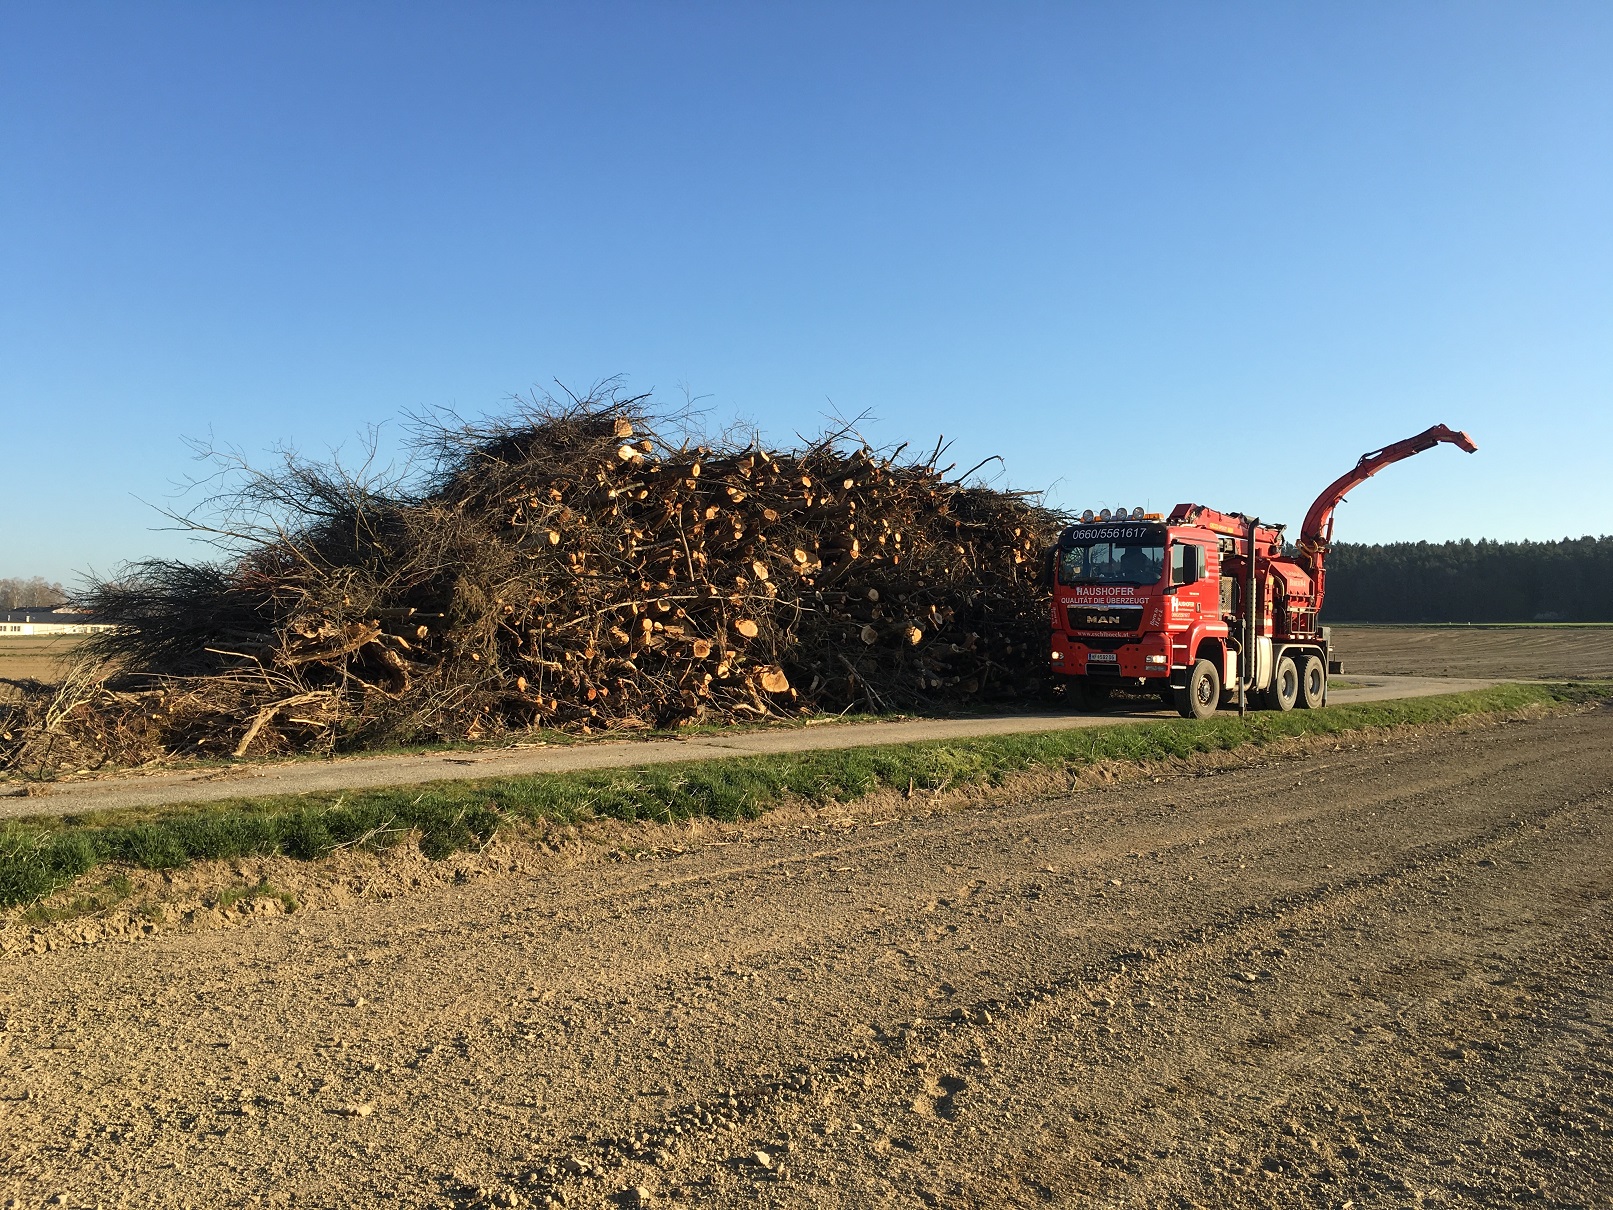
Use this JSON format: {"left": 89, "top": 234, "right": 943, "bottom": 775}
{"left": 0, "top": 676, "right": 1495, "bottom": 818}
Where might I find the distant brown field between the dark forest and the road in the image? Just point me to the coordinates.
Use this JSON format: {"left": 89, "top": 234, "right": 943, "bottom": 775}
{"left": 1332, "top": 626, "right": 1613, "bottom": 681}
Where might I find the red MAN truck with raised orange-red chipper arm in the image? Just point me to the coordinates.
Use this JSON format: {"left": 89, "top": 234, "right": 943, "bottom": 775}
{"left": 1048, "top": 424, "right": 1478, "bottom": 718}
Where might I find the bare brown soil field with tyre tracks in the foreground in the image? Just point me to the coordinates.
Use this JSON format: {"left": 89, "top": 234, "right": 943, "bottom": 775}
{"left": 0, "top": 708, "right": 1613, "bottom": 1208}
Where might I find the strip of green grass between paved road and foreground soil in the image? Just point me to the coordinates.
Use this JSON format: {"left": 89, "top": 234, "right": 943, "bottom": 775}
{"left": 0, "top": 684, "right": 1613, "bottom": 907}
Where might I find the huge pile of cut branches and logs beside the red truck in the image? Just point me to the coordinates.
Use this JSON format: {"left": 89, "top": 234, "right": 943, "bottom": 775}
{"left": 0, "top": 398, "right": 1060, "bottom": 765}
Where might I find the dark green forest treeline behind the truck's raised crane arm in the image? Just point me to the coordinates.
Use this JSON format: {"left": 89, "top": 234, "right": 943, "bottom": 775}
{"left": 1323, "top": 536, "right": 1613, "bottom": 621}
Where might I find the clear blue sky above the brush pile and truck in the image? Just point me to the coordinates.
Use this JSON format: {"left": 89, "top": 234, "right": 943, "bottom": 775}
{"left": 0, "top": 0, "right": 1613, "bottom": 582}
